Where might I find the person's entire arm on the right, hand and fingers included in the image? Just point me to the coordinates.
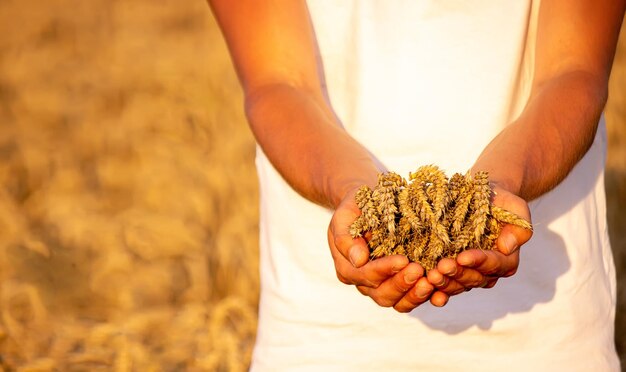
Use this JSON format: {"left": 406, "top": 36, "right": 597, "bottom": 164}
{"left": 429, "top": 0, "right": 626, "bottom": 294}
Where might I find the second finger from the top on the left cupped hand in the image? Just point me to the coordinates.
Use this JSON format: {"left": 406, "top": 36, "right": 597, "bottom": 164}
{"left": 359, "top": 263, "right": 424, "bottom": 307}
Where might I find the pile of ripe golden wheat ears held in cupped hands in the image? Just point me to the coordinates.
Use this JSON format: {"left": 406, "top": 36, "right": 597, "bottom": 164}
{"left": 350, "top": 165, "right": 532, "bottom": 270}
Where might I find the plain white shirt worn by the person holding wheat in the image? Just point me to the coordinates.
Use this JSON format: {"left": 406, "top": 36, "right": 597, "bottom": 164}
{"left": 252, "top": 0, "right": 619, "bottom": 371}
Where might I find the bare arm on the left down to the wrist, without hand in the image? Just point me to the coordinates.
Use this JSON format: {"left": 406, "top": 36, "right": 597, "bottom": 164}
{"left": 210, "top": 0, "right": 379, "bottom": 208}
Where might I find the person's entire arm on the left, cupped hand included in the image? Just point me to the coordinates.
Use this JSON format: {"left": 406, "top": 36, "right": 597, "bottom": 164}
{"left": 209, "top": 0, "right": 432, "bottom": 306}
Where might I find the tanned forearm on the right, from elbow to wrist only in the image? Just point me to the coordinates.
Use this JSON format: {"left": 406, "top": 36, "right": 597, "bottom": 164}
{"left": 473, "top": 71, "right": 607, "bottom": 200}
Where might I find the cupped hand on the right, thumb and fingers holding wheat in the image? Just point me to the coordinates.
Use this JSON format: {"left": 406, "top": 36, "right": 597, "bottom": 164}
{"left": 428, "top": 185, "right": 532, "bottom": 302}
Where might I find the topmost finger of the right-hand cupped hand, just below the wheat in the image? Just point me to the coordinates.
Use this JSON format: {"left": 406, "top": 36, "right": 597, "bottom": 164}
{"left": 457, "top": 249, "right": 519, "bottom": 277}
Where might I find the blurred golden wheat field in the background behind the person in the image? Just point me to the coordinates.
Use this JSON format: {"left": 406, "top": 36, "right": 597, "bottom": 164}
{"left": 0, "top": 0, "right": 626, "bottom": 371}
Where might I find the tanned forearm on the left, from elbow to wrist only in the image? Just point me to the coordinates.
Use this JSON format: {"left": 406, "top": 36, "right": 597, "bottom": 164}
{"left": 246, "top": 84, "right": 380, "bottom": 208}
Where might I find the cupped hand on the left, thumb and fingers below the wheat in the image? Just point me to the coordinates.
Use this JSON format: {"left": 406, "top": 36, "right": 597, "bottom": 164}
{"left": 328, "top": 189, "right": 433, "bottom": 312}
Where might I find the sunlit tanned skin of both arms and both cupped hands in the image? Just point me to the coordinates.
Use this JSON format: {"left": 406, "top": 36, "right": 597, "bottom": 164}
{"left": 209, "top": 0, "right": 626, "bottom": 312}
